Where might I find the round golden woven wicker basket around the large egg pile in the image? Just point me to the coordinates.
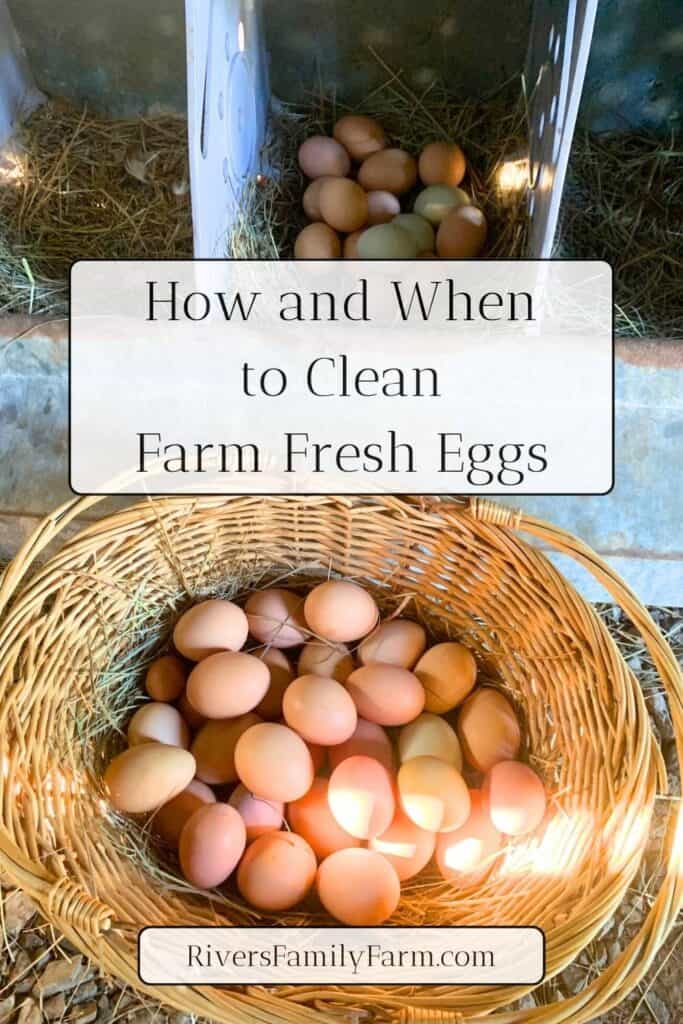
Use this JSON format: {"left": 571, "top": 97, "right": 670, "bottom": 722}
{"left": 0, "top": 498, "right": 683, "bottom": 1024}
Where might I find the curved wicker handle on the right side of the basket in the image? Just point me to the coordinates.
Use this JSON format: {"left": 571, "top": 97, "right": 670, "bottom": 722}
{"left": 405, "top": 498, "right": 683, "bottom": 1024}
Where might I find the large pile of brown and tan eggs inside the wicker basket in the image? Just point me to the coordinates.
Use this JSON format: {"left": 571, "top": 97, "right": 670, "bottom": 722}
{"left": 104, "top": 580, "right": 546, "bottom": 925}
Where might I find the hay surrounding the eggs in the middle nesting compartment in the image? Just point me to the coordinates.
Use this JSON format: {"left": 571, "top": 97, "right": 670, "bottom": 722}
{"left": 227, "top": 54, "right": 528, "bottom": 259}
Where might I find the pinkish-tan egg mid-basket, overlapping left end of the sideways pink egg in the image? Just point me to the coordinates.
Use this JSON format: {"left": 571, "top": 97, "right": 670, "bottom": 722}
{"left": 283, "top": 676, "right": 357, "bottom": 746}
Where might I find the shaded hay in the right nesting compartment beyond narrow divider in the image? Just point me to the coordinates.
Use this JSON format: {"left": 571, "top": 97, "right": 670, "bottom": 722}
{"left": 557, "top": 132, "right": 683, "bottom": 339}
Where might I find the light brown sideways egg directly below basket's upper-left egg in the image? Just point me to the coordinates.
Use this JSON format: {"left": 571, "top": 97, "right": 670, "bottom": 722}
{"left": 187, "top": 651, "right": 270, "bottom": 719}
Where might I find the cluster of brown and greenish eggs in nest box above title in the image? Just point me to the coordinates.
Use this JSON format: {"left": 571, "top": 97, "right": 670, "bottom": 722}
{"left": 294, "top": 114, "right": 486, "bottom": 259}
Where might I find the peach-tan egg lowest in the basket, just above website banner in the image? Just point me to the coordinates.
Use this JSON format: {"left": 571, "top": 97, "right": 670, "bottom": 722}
{"left": 317, "top": 850, "right": 400, "bottom": 927}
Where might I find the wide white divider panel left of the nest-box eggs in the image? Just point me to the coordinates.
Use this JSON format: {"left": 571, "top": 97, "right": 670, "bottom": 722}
{"left": 185, "top": 0, "right": 268, "bottom": 257}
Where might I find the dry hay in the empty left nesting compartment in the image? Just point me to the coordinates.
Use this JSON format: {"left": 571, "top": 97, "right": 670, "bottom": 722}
{"left": 0, "top": 100, "right": 193, "bottom": 315}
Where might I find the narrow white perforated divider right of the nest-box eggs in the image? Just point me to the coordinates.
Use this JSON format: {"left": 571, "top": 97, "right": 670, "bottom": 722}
{"left": 526, "top": 0, "right": 598, "bottom": 257}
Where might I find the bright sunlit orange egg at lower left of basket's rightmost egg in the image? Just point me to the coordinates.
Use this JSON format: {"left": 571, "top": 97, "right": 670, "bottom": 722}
{"left": 435, "top": 790, "right": 503, "bottom": 888}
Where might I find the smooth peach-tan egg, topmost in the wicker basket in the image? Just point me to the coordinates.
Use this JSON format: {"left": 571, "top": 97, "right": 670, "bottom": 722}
{"left": 303, "top": 580, "right": 379, "bottom": 643}
